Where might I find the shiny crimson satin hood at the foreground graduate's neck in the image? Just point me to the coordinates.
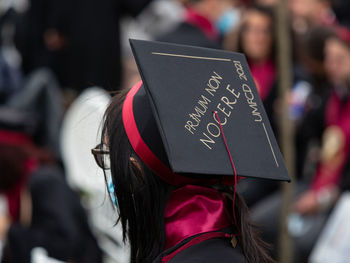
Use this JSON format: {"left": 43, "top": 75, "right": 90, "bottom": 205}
{"left": 164, "top": 185, "right": 233, "bottom": 249}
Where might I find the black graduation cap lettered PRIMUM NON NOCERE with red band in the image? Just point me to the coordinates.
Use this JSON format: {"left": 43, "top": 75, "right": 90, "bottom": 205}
{"left": 123, "top": 40, "right": 290, "bottom": 188}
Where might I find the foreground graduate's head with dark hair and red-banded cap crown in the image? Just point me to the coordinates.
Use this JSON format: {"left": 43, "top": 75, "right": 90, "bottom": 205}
{"left": 100, "top": 83, "right": 224, "bottom": 262}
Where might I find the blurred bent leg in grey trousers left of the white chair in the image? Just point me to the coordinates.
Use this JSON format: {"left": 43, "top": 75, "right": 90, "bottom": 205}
{"left": 6, "top": 68, "right": 64, "bottom": 160}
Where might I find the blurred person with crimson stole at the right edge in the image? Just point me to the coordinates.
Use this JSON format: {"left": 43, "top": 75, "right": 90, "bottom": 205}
{"left": 293, "top": 25, "right": 350, "bottom": 262}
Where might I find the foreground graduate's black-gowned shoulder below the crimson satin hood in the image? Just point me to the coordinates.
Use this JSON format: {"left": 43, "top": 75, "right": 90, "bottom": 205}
{"left": 153, "top": 238, "right": 246, "bottom": 263}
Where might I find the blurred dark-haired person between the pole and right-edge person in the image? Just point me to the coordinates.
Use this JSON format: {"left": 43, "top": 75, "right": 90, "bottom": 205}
{"left": 289, "top": 27, "right": 333, "bottom": 180}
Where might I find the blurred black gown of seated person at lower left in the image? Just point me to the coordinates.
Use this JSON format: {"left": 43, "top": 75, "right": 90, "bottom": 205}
{"left": 4, "top": 167, "right": 102, "bottom": 263}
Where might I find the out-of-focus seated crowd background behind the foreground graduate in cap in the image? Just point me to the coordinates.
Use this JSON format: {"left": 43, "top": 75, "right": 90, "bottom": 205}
{"left": 0, "top": 0, "right": 350, "bottom": 263}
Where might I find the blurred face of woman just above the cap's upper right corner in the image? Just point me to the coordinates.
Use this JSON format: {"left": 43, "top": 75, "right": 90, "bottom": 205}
{"left": 238, "top": 7, "right": 275, "bottom": 62}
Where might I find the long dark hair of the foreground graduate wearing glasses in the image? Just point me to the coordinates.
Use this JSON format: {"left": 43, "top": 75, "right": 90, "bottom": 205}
{"left": 102, "top": 90, "right": 274, "bottom": 263}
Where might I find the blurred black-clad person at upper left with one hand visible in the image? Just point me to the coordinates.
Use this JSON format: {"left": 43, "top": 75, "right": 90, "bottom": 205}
{"left": 16, "top": 0, "right": 151, "bottom": 92}
